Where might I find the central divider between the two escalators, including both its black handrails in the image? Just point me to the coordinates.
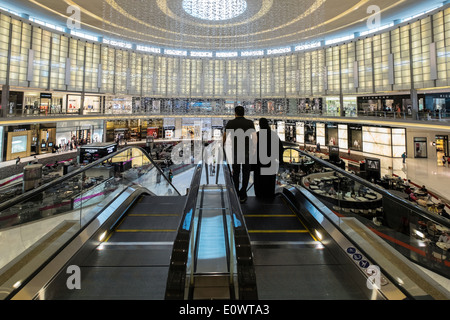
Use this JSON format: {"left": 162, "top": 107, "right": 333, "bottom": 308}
{"left": 165, "top": 164, "right": 257, "bottom": 300}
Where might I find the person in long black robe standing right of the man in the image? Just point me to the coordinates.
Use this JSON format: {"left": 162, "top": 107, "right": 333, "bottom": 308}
{"left": 254, "top": 118, "right": 284, "bottom": 199}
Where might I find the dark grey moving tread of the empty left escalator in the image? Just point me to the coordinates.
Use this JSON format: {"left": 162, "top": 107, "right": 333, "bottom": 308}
{"left": 35, "top": 194, "right": 186, "bottom": 300}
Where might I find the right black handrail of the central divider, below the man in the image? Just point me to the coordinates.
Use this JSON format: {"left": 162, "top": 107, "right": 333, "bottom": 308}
{"left": 223, "top": 162, "right": 258, "bottom": 300}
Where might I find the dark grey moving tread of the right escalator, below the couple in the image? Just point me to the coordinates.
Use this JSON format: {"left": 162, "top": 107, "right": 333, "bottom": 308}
{"left": 242, "top": 190, "right": 374, "bottom": 300}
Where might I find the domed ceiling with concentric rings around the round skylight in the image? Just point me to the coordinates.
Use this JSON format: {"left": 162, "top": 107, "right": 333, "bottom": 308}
{"left": 0, "top": 0, "right": 442, "bottom": 50}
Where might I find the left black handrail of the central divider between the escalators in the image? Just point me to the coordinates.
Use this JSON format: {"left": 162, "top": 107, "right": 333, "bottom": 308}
{"left": 165, "top": 162, "right": 203, "bottom": 300}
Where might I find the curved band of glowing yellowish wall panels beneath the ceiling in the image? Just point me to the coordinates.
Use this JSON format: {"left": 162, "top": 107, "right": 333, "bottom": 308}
{"left": 0, "top": 9, "right": 450, "bottom": 100}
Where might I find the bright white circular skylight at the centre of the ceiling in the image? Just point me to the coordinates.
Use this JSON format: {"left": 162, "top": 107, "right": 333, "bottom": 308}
{"left": 183, "top": 0, "right": 247, "bottom": 21}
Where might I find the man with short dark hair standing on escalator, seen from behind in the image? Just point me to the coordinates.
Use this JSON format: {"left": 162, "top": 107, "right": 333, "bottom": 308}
{"left": 223, "top": 106, "right": 257, "bottom": 203}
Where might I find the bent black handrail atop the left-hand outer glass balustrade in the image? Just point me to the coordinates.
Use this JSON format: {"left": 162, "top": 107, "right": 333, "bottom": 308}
{"left": 0, "top": 146, "right": 181, "bottom": 212}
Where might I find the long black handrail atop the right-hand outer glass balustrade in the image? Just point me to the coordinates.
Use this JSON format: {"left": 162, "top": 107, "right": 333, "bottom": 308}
{"left": 285, "top": 147, "right": 450, "bottom": 228}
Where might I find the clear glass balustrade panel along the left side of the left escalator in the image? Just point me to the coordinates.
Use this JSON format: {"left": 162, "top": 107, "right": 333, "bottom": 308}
{"left": 0, "top": 148, "right": 179, "bottom": 298}
